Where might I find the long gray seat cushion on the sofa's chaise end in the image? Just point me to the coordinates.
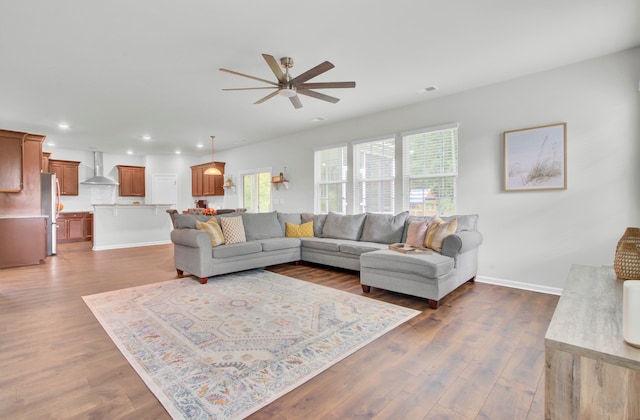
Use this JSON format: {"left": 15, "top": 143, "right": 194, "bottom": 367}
{"left": 360, "top": 250, "right": 454, "bottom": 278}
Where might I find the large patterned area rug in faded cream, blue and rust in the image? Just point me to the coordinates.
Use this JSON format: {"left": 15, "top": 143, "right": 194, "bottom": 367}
{"left": 83, "top": 270, "right": 419, "bottom": 419}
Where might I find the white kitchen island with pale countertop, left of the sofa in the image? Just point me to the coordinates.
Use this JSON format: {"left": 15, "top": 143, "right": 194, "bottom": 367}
{"left": 93, "top": 204, "right": 173, "bottom": 251}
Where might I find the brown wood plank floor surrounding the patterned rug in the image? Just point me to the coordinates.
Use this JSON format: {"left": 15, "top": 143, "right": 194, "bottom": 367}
{"left": 0, "top": 242, "right": 558, "bottom": 419}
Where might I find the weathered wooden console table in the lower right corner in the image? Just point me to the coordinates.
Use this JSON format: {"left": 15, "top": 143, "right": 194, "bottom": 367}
{"left": 545, "top": 265, "right": 640, "bottom": 419}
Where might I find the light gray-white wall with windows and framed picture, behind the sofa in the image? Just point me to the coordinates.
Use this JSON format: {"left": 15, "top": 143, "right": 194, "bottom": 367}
{"left": 216, "top": 48, "right": 640, "bottom": 289}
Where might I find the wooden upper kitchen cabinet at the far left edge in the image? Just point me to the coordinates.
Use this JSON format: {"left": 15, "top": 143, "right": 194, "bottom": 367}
{"left": 0, "top": 130, "right": 27, "bottom": 192}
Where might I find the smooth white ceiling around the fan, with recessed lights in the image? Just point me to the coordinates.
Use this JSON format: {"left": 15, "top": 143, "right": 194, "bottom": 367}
{"left": 0, "top": 0, "right": 640, "bottom": 154}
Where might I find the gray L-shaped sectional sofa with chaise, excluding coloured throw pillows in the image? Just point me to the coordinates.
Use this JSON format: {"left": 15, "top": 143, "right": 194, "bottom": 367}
{"left": 170, "top": 210, "right": 482, "bottom": 308}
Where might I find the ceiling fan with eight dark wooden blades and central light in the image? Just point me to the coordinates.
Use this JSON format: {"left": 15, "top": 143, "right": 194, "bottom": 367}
{"left": 220, "top": 54, "right": 356, "bottom": 109}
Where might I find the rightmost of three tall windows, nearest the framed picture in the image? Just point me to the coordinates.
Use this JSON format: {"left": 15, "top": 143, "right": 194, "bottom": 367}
{"left": 402, "top": 124, "right": 458, "bottom": 216}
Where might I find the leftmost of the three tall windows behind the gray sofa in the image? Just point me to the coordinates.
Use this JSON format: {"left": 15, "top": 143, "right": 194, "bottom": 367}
{"left": 315, "top": 146, "right": 348, "bottom": 214}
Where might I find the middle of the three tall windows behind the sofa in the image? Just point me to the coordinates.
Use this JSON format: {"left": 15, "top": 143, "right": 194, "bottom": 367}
{"left": 353, "top": 137, "right": 396, "bottom": 214}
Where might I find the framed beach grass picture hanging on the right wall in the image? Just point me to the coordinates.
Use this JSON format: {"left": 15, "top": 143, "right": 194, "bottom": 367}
{"left": 504, "top": 123, "right": 567, "bottom": 191}
